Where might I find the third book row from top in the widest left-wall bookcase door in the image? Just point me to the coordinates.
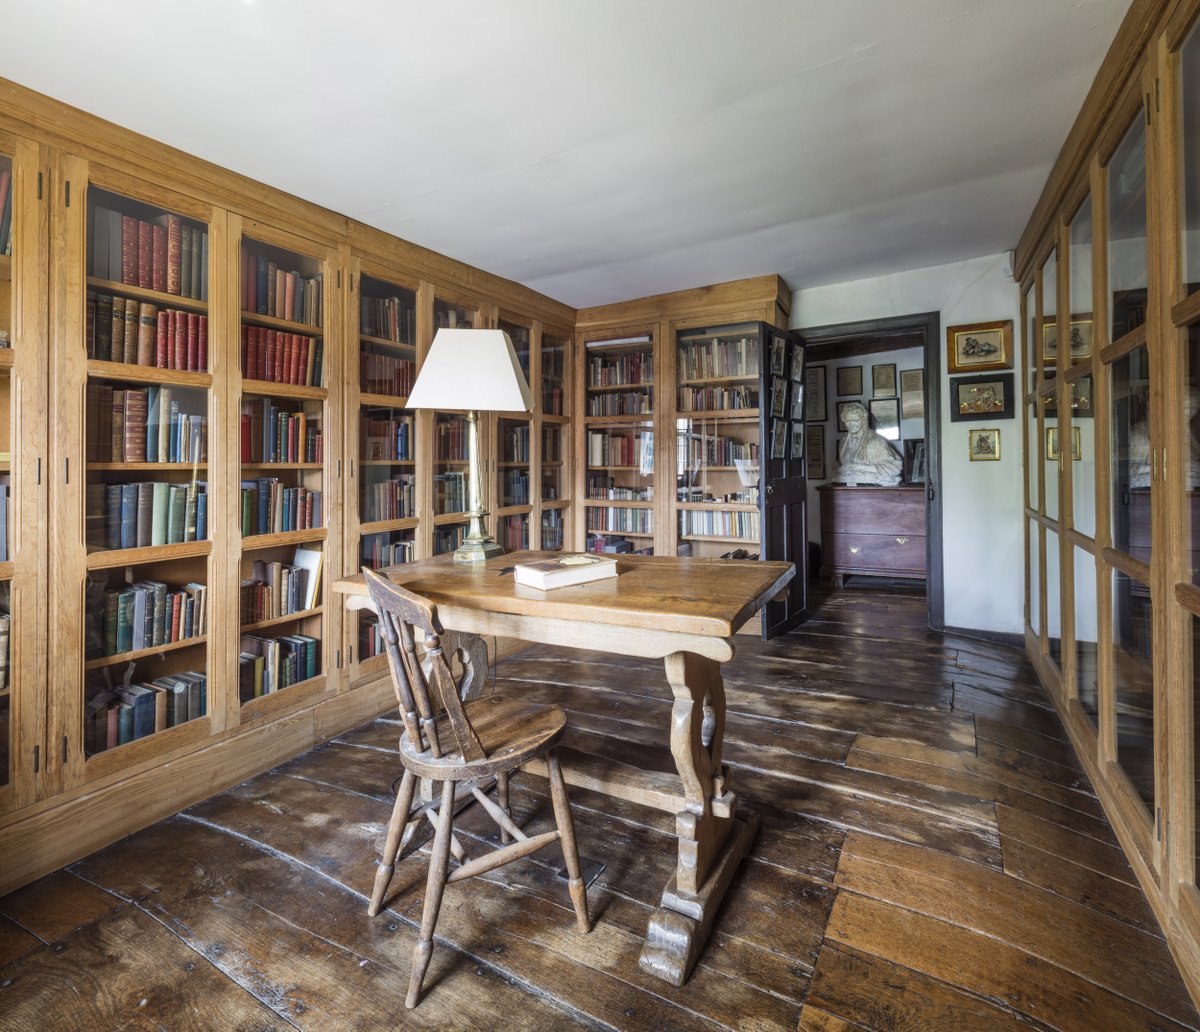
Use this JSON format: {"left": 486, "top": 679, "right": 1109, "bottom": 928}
{"left": 84, "top": 380, "right": 209, "bottom": 462}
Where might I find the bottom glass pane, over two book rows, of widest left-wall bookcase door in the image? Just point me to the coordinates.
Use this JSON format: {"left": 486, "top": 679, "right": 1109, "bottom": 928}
{"left": 82, "top": 556, "right": 209, "bottom": 756}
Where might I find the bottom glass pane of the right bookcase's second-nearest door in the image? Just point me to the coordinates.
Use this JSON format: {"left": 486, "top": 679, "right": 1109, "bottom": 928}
{"left": 1111, "top": 570, "right": 1154, "bottom": 814}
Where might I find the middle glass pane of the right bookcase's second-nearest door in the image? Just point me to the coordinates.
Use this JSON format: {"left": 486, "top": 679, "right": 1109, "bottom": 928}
{"left": 1109, "top": 346, "right": 1151, "bottom": 564}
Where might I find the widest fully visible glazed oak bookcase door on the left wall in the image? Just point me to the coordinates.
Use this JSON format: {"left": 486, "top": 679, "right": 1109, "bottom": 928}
{"left": 49, "top": 157, "right": 227, "bottom": 784}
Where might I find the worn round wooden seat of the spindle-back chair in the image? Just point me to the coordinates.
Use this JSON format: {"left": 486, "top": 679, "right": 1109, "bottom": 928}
{"left": 400, "top": 695, "right": 566, "bottom": 781}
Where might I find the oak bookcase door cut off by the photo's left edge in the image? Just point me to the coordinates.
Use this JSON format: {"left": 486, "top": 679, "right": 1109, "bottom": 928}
{"left": 0, "top": 133, "right": 47, "bottom": 812}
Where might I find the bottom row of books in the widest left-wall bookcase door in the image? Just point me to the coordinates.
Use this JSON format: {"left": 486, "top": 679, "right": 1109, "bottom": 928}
{"left": 83, "top": 670, "right": 208, "bottom": 756}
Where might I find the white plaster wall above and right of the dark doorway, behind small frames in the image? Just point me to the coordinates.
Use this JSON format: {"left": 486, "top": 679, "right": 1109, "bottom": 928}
{"left": 792, "top": 254, "right": 1025, "bottom": 634}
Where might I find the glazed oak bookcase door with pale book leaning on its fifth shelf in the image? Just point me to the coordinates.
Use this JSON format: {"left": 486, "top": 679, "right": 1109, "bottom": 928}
{"left": 227, "top": 218, "right": 342, "bottom": 724}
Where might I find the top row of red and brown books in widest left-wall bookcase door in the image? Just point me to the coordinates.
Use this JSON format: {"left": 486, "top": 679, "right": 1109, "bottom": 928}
{"left": 88, "top": 204, "right": 209, "bottom": 301}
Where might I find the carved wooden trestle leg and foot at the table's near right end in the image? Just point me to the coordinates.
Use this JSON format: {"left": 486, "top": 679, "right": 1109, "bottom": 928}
{"left": 640, "top": 653, "right": 758, "bottom": 985}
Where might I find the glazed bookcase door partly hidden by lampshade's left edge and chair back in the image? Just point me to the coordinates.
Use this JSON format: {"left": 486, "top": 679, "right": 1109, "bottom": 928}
{"left": 346, "top": 264, "right": 420, "bottom": 680}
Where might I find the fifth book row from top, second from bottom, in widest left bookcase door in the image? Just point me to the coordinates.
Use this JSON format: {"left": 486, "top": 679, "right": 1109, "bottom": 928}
{"left": 88, "top": 581, "right": 209, "bottom": 659}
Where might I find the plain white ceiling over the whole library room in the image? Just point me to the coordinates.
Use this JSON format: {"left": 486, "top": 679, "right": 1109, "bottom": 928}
{"left": 0, "top": 0, "right": 1128, "bottom": 307}
